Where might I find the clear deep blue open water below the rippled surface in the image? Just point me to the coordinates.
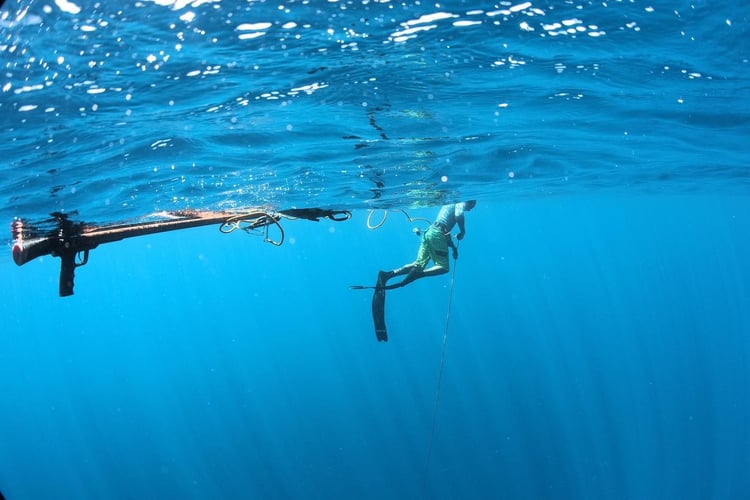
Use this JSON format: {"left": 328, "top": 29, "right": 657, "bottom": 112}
{"left": 0, "top": 192, "right": 750, "bottom": 499}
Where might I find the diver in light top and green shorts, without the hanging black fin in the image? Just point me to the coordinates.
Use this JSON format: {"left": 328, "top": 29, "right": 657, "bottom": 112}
{"left": 375, "top": 200, "right": 477, "bottom": 290}
